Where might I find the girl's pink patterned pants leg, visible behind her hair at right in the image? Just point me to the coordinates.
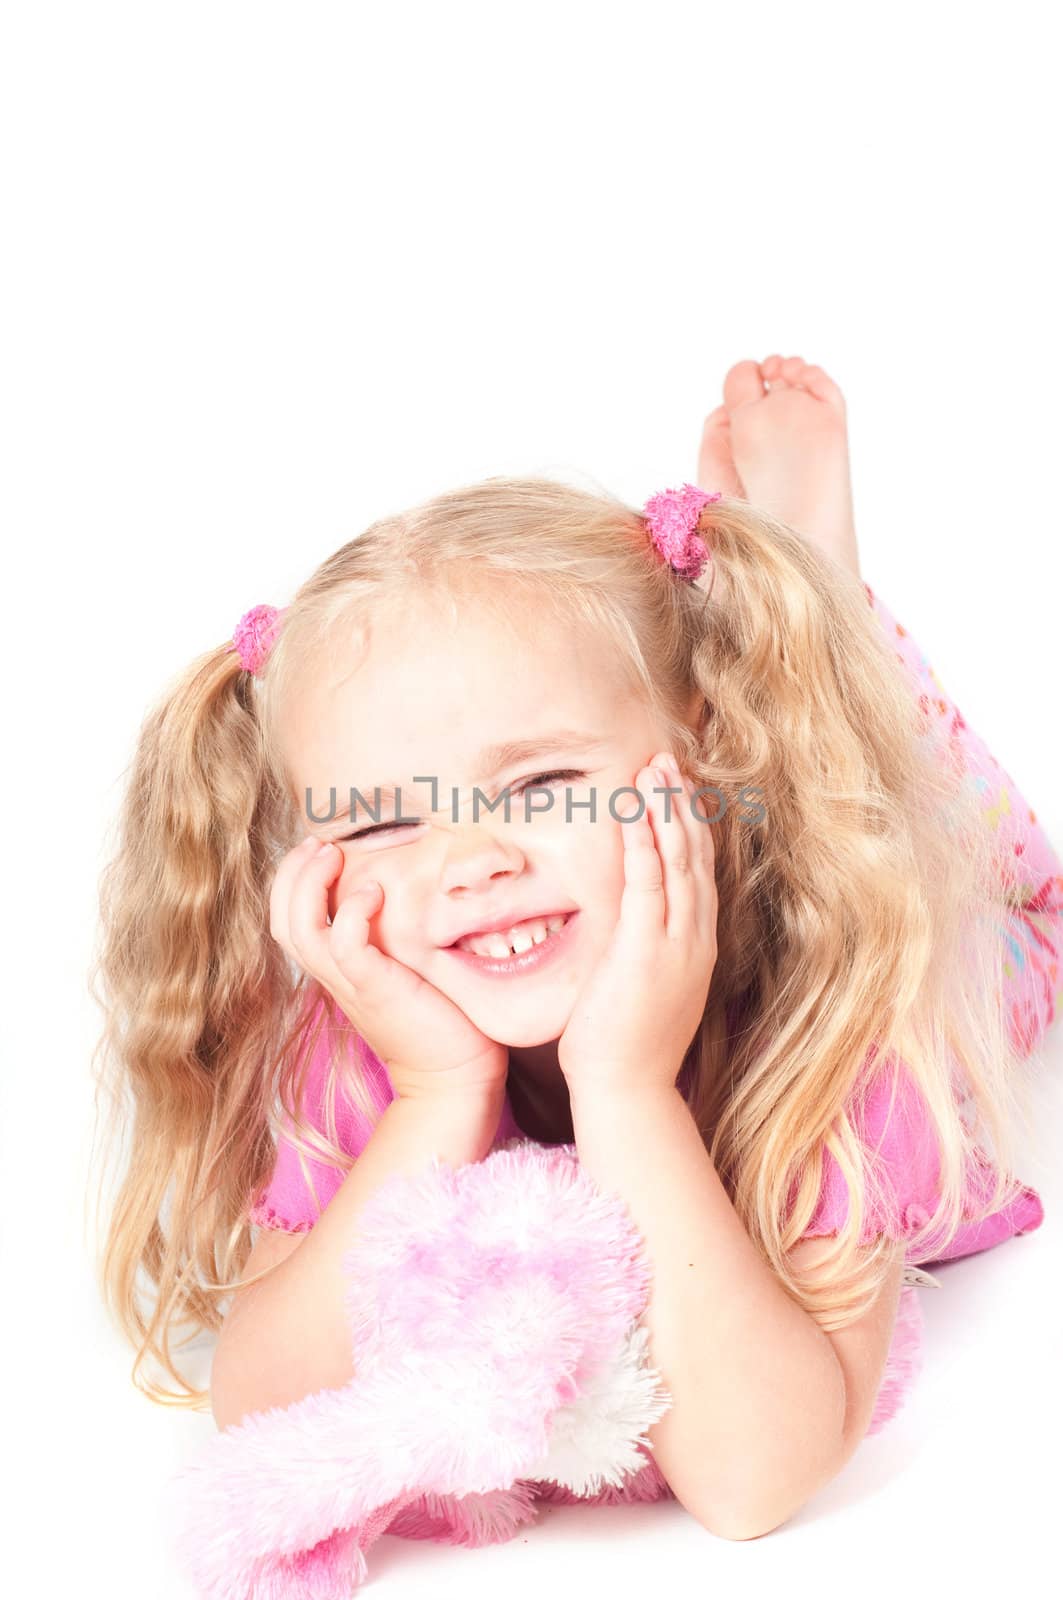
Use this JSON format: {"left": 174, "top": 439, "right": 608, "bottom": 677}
{"left": 864, "top": 584, "right": 1063, "bottom": 1056}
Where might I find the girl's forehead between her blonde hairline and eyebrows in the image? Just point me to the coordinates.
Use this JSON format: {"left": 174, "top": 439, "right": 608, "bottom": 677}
{"left": 282, "top": 597, "right": 639, "bottom": 792}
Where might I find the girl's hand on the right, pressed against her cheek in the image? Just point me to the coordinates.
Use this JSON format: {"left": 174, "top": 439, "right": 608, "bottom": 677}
{"left": 557, "top": 755, "right": 719, "bottom": 1090}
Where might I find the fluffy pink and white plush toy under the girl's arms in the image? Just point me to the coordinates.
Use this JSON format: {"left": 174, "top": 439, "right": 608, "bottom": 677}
{"left": 171, "top": 1139, "right": 921, "bottom": 1600}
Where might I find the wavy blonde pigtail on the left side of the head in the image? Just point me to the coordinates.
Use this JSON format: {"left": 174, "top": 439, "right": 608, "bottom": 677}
{"left": 90, "top": 646, "right": 295, "bottom": 1410}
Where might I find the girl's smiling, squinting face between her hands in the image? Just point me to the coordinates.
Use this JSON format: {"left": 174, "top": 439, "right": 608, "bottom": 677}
{"left": 283, "top": 602, "right": 679, "bottom": 1046}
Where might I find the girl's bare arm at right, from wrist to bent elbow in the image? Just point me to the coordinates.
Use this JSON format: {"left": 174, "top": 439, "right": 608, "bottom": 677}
{"left": 572, "top": 1082, "right": 903, "bottom": 1539}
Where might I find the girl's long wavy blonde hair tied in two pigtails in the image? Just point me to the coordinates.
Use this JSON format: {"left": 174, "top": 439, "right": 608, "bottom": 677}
{"left": 94, "top": 477, "right": 1021, "bottom": 1410}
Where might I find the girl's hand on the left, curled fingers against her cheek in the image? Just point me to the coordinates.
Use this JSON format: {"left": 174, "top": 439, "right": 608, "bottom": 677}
{"left": 269, "top": 838, "right": 509, "bottom": 1099}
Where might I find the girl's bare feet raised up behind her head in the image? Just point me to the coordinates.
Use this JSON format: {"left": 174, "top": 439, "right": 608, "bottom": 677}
{"left": 698, "top": 355, "right": 860, "bottom": 578}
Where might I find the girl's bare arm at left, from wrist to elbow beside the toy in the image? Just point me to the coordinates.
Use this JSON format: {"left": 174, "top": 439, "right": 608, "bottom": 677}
{"left": 210, "top": 1085, "right": 504, "bottom": 1429}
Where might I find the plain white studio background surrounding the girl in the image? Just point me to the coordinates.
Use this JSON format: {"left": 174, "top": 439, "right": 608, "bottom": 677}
{"left": 0, "top": 0, "right": 1063, "bottom": 1600}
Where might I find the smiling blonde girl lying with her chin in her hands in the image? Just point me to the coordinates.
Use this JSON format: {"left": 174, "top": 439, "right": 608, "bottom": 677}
{"left": 99, "top": 357, "right": 1063, "bottom": 1538}
